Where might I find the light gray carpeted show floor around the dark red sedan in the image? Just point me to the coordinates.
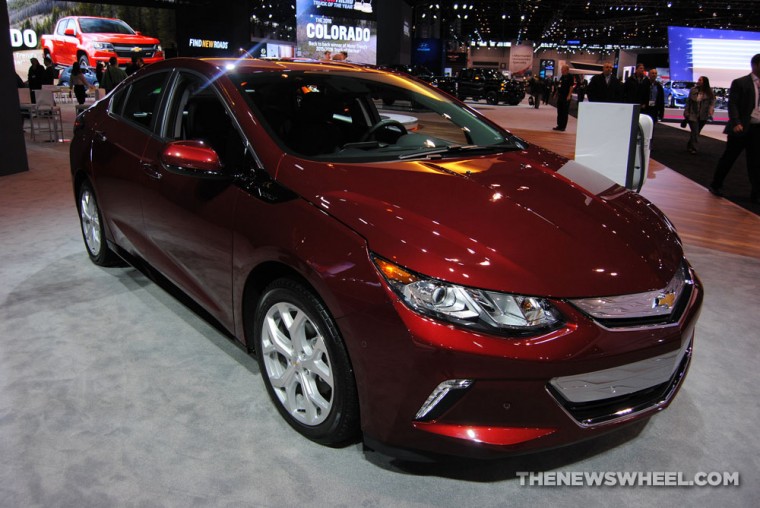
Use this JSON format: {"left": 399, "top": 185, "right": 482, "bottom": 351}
{"left": 0, "top": 106, "right": 760, "bottom": 507}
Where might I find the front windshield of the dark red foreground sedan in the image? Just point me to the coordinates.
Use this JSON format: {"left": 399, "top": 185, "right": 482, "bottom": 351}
{"left": 230, "top": 69, "right": 524, "bottom": 162}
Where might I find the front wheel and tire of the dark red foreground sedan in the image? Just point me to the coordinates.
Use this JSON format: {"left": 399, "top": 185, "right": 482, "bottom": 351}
{"left": 254, "top": 279, "right": 359, "bottom": 446}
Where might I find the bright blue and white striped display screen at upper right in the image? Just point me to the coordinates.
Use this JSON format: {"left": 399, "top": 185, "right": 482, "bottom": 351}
{"left": 668, "top": 26, "right": 760, "bottom": 88}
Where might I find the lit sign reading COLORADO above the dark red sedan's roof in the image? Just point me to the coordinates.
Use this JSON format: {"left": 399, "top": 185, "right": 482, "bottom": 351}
{"left": 296, "top": 0, "right": 377, "bottom": 64}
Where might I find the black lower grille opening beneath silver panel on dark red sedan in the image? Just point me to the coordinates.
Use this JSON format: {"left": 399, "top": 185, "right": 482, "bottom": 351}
{"left": 546, "top": 343, "right": 692, "bottom": 427}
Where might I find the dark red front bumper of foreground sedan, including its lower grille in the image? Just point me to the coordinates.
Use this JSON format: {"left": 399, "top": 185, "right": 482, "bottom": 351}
{"left": 340, "top": 270, "right": 703, "bottom": 458}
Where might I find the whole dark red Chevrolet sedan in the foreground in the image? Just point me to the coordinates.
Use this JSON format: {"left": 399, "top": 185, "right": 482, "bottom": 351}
{"left": 71, "top": 59, "right": 703, "bottom": 457}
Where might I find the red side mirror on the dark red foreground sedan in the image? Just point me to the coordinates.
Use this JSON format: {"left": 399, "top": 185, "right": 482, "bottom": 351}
{"left": 161, "top": 141, "right": 230, "bottom": 180}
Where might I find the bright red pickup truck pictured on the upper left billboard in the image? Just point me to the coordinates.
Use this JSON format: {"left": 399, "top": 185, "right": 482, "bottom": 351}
{"left": 40, "top": 16, "right": 164, "bottom": 67}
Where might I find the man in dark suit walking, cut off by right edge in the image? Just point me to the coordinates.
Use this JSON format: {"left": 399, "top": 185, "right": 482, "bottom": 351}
{"left": 710, "top": 53, "right": 760, "bottom": 203}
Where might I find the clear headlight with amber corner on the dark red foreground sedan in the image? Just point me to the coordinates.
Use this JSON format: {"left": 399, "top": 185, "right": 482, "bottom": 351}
{"left": 373, "top": 257, "right": 564, "bottom": 337}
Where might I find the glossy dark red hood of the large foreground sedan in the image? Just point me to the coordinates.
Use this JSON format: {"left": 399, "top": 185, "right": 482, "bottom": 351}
{"left": 276, "top": 147, "right": 683, "bottom": 297}
